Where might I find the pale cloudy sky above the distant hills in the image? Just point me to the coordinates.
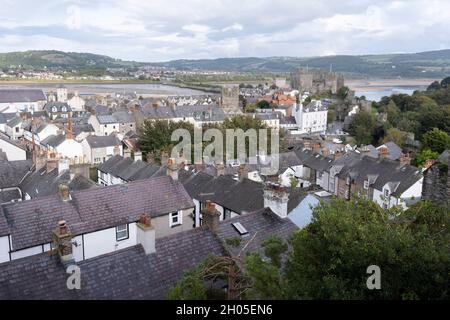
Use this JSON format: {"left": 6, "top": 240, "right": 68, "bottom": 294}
{"left": 0, "top": 0, "right": 450, "bottom": 61}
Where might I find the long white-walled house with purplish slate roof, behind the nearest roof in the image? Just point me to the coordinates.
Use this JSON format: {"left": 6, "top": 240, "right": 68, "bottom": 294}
{"left": 0, "top": 176, "right": 194, "bottom": 263}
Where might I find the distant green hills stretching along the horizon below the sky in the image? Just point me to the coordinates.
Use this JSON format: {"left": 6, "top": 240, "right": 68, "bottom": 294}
{"left": 0, "top": 50, "right": 450, "bottom": 78}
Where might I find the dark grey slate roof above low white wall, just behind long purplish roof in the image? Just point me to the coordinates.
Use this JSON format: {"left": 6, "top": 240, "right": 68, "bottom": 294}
{"left": 98, "top": 155, "right": 166, "bottom": 182}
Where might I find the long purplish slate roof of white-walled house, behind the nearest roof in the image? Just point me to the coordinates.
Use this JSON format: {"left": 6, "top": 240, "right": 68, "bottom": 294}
{"left": 3, "top": 176, "right": 194, "bottom": 250}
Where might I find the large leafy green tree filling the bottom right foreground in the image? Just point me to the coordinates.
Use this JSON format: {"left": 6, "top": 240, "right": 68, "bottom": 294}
{"left": 283, "top": 198, "right": 450, "bottom": 299}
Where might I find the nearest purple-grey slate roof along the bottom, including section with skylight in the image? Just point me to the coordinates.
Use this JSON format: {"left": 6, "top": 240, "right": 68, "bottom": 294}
{"left": 0, "top": 207, "right": 297, "bottom": 300}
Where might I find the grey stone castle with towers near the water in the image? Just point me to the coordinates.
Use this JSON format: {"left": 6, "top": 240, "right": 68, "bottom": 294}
{"left": 291, "top": 68, "right": 344, "bottom": 94}
